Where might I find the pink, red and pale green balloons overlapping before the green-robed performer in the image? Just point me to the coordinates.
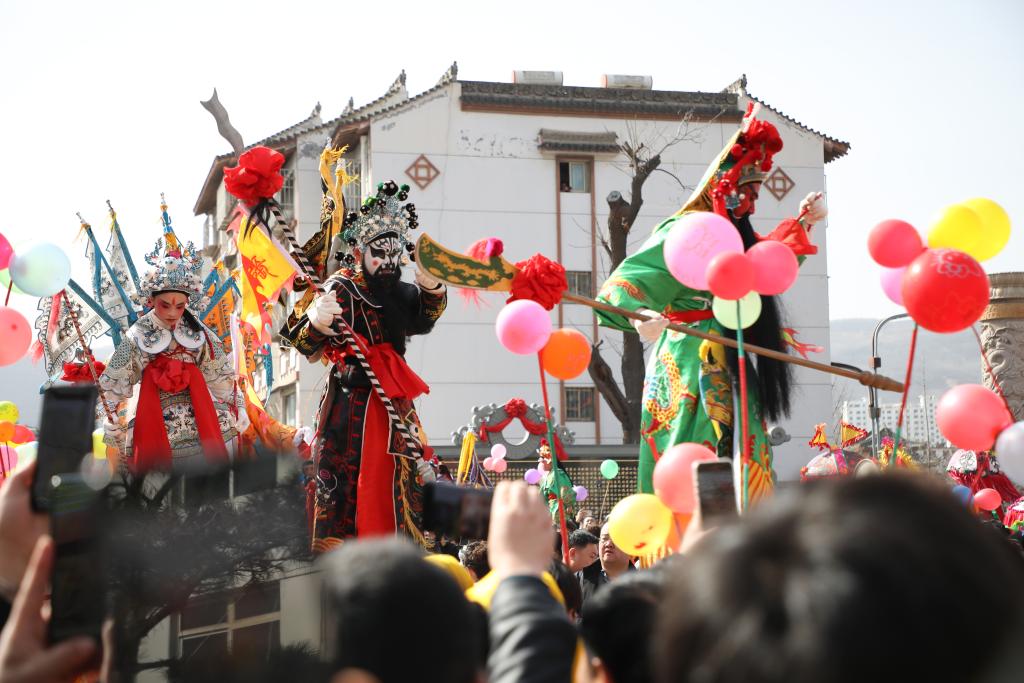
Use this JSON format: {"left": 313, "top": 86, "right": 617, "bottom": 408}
{"left": 664, "top": 211, "right": 800, "bottom": 330}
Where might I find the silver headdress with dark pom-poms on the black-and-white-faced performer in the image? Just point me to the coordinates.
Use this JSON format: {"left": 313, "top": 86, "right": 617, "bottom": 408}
{"left": 341, "top": 180, "right": 420, "bottom": 265}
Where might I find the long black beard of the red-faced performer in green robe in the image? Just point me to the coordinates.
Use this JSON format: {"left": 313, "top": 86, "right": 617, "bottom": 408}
{"left": 725, "top": 213, "right": 793, "bottom": 422}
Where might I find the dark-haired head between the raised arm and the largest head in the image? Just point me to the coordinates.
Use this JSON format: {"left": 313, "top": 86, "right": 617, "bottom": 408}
{"left": 577, "top": 571, "right": 664, "bottom": 683}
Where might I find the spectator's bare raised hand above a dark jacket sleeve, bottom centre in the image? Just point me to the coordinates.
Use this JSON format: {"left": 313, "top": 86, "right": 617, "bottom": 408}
{"left": 487, "top": 481, "right": 551, "bottom": 578}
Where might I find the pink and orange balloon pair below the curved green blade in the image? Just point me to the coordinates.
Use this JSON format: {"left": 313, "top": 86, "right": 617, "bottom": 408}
{"left": 495, "top": 299, "right": 591, "bottom": 380}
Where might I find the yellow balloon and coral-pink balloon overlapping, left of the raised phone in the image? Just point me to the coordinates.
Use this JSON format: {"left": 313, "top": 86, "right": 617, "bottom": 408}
{"left": 605, "top": 443, "right": 718, "bottom": 555}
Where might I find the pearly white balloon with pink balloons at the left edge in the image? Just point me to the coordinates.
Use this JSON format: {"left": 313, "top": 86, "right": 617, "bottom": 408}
{"left": 0, "top": 233, "right": 71, "bottom": 367}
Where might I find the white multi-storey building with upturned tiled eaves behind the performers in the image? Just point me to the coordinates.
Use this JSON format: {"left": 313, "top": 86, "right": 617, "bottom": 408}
{"left": 195, "top": 65, "right": 849, "bottom": 479}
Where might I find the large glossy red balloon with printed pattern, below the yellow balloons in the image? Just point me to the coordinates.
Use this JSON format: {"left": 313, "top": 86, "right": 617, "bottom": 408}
{"left": 901, "top": 249, "right": 988, "bottom": 332}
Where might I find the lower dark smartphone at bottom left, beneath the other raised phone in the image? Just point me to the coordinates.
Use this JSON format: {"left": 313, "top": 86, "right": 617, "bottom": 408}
{"left": 47, "top": 473, "right": 108, "bottom": 644}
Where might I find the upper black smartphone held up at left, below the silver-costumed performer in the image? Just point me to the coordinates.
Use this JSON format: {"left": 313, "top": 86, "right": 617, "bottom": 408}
{"left": 32, "top": 384, "right": 97, "bottom": 512}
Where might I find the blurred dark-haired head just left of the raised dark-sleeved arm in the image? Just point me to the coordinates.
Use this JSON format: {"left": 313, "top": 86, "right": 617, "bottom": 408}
{"left": 322, "top": 539, "right": 486, "bottom": 683}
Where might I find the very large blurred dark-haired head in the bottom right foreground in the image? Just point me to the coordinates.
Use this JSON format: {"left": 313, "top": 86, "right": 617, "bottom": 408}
{"left": 653, "top": 475, "right": 1024, "bottom": 683}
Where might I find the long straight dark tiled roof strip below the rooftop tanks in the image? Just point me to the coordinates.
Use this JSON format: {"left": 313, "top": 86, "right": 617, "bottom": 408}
{"left": 460, "top": 81, "right": 741, "bottom": 121}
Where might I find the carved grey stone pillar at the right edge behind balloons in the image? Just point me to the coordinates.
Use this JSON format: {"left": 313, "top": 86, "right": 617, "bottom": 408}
{"left": 981, "top": 272, "right": 1024, "bottom": 421}
